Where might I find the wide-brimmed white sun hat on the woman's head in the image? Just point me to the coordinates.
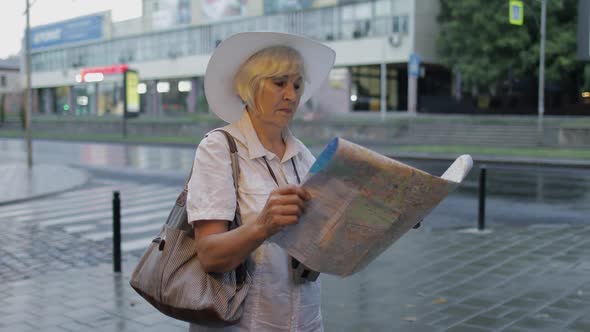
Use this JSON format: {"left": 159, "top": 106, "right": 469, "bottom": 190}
{"left": 205, "top": 32, "right": 336, "bottom": 123}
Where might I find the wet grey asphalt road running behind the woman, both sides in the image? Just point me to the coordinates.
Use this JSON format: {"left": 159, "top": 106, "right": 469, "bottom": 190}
{"left": 0, "top": 139, "right": 590, "bottom": 228}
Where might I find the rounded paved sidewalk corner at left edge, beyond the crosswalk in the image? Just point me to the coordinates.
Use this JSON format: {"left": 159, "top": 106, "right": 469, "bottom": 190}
{"left": 0, "top": 162, "right": 88, "bottom": 206}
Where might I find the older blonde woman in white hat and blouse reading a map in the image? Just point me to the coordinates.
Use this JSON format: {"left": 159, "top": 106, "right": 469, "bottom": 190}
{"left": 187, "top": 32, "right": 335, "bottom": 331}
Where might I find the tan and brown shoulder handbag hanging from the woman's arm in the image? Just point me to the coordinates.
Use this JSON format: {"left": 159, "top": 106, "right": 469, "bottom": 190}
{"left": 130, "top": 129, "right": 251, "bottom": 326}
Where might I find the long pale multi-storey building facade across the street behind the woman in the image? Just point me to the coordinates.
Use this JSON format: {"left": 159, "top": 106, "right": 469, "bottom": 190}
{"left": 24, "top": 0, "right": 451, "bottom": 115}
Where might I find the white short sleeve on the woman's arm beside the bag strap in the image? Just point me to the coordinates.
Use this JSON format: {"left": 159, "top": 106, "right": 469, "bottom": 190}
{"left": 186, "top": 132, "right": 236, "bottom": 224}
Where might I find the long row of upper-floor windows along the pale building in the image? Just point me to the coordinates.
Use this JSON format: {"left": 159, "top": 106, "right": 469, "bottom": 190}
{"left": 32, "top": 0, "right": 409, "bottom": 72}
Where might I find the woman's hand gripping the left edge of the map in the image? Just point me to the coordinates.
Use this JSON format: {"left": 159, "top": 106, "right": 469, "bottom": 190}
{"left": 256, "top": 185, "right": 311, "bottom": 238}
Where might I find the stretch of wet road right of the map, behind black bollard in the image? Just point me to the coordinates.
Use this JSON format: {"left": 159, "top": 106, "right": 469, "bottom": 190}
{"left": 408, "top": 161, "right": 590, "bottom": 227}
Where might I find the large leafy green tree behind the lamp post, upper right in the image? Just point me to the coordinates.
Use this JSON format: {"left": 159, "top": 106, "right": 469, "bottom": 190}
{"left": 437, "top": 0, "right": 590, "bottom": 95}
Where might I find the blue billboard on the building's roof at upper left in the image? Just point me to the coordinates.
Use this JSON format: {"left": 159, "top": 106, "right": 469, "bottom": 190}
{"left": 31, "top": 15, "right": 104, "bottom": 50}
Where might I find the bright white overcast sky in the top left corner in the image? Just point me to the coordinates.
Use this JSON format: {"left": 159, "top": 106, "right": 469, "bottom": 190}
{"left": 0, "top": 0, "right": 141, "bottom": 59}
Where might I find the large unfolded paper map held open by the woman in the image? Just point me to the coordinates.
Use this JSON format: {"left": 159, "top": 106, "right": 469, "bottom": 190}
{"left": 270, "top": 138, "right": 473, "bottom": 276}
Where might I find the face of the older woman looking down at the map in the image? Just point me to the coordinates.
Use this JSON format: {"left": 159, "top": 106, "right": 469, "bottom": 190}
{"left": 251, "top": 74, "right": 303, "bottom": 128}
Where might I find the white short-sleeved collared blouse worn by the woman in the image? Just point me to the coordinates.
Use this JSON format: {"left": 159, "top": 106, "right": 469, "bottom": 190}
{"left": 187, "top": 112, "right": 323, "bottom": 332}
